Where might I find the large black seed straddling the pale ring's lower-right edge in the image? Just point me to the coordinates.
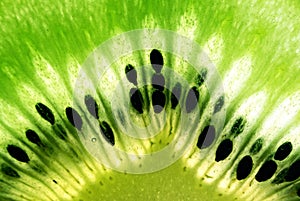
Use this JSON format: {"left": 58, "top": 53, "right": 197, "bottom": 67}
{"left": 197, "top": 125, "right": 216, "bottom": 149}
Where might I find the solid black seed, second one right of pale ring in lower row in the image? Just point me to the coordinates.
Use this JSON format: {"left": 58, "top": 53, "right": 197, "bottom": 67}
{"left": 236, "top": 156, "right": 253, "bottom": 180}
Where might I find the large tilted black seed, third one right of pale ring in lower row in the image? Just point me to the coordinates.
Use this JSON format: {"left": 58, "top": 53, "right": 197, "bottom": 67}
{"left": 255, "top": 160, "right": 277, "bottom": 182}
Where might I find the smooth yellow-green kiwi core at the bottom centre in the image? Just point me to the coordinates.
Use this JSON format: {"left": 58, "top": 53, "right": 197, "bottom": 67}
{"left": 76, "top": 162, "right": 237, "bottom": 201}
